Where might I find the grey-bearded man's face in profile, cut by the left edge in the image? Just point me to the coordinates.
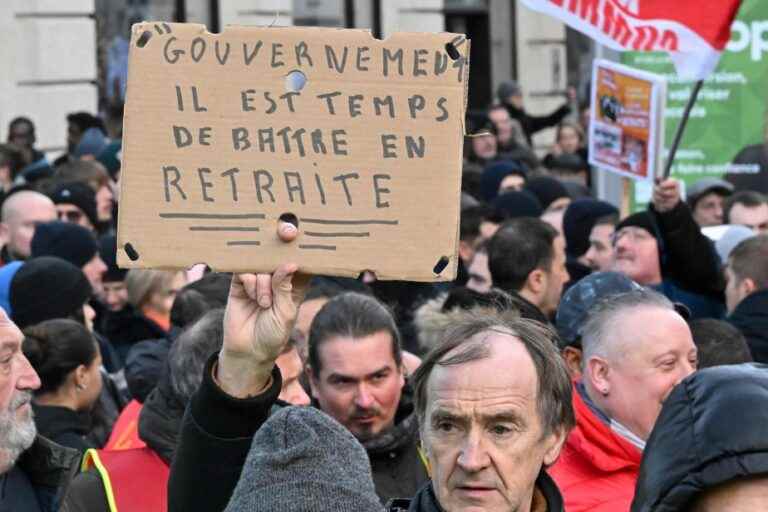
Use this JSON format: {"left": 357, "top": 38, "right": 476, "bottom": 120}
{"left": 0, "top": 309, "right": 40, "bottom": 474}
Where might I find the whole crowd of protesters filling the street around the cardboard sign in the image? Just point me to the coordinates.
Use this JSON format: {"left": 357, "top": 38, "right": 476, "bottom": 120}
{"left": 0, "top": 77, "right": 768, "bottom": 512}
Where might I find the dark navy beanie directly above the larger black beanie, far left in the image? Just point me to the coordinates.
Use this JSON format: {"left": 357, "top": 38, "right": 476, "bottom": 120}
{"left": 31, "top": 221, "right": 99, "bottom": 268}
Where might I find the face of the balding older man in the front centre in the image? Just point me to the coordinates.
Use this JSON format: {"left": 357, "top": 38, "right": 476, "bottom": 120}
{"left": 421, "top": 332, "right": 565, "bottom": 512}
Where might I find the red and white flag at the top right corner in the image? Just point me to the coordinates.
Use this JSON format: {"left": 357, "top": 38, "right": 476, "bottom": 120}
{"left": 521, "top": 0, "right": 741, "bottom": 80}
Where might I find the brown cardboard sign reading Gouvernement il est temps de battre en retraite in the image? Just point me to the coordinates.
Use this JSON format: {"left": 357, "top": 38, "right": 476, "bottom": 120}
{"left": 118, "top": 23, "right": 469, "bottom": 281}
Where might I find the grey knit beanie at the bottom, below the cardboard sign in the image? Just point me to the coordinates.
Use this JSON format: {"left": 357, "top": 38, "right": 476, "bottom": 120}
{"left": 225, "top": 407, "right": 384, "bottom": 512}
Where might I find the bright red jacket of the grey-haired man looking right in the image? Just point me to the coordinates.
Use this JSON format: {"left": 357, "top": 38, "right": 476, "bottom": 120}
{"left": 548, "top": 386, "right": 642, "bottom": 512}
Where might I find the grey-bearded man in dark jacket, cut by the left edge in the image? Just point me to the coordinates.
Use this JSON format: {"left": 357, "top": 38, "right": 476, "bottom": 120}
{"left": 0, "top": 308, "right": 80, "bottom": 512}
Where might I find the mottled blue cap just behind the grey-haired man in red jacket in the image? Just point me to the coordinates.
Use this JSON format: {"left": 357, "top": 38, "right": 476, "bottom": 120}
{"left": 555, "top": 272, "right": 642, "bottom": 349}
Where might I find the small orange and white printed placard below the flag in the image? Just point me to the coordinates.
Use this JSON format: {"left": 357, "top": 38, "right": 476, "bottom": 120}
{"left": 589, "top": 60, "right": 666, "bottom": 182}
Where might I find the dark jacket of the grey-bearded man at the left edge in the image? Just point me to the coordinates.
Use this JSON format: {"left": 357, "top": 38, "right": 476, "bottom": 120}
{"left": 0, "top": 436, "right": 81, "bottom": 512}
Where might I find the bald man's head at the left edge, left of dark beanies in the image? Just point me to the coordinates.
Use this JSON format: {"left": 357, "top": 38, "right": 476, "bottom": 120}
{"left": 0, "top": 190, "right": 56, "bottom": 260}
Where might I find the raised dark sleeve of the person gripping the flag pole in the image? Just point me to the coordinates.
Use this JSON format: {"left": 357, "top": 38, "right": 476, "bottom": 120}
{"left": 650, "top": 201, "right": 725, "bottom": 297}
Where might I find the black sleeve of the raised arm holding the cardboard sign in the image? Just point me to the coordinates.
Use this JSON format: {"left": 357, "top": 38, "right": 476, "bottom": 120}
{"left": 168, "top": 353, "right": 282, "bottom": 512}
